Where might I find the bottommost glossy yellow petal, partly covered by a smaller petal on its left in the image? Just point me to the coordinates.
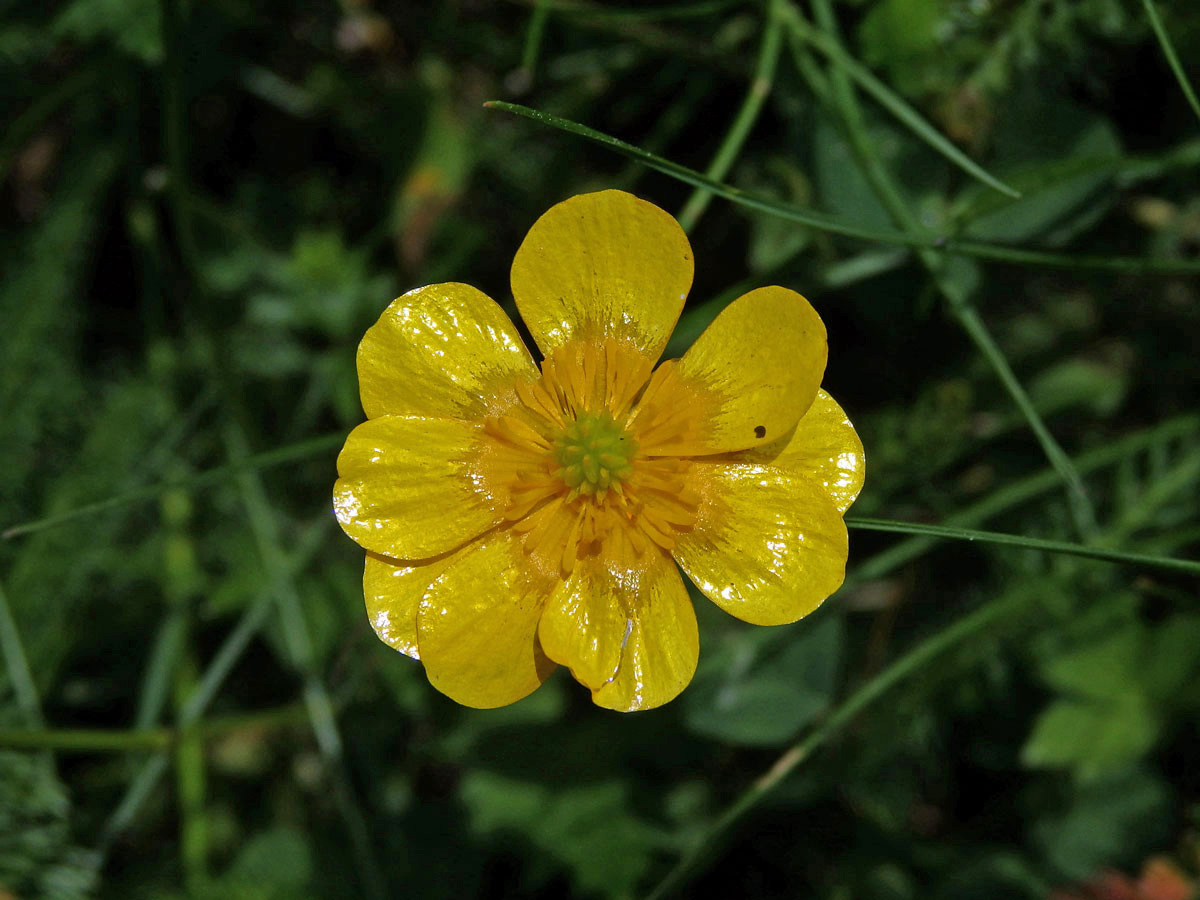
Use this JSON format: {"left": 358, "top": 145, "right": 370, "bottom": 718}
{"left": 572, "top": 550, "right": 700, "bottom": 713}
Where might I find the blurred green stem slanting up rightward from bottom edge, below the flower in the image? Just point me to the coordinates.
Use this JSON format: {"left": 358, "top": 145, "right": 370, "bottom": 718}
{"left": 646, "top": 594, "right": 1026, "bottom": 900}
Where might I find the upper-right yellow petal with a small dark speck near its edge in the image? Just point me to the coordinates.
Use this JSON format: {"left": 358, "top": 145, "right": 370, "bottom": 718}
{"left": 654, "top": 287, "right": 828, "bottom": 456}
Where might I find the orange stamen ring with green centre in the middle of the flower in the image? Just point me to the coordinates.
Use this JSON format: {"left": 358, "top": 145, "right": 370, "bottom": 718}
{"left": 481, "top": 340, "right": 700, "bottom": 575}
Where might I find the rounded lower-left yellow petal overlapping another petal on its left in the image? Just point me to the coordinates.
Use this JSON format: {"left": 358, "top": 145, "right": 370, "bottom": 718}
{"left": 416, "top": 529, "right": 554, "bottom": 709}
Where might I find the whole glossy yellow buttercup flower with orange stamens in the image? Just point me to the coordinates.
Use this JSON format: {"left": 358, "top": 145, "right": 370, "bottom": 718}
{"left": 334, "top": 191, "right": 864, "bottom": 710}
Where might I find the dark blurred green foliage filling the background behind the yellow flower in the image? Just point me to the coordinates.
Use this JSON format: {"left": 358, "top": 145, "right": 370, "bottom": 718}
{"left": 0, "top": 0, "right": 1200, "bottom": 900}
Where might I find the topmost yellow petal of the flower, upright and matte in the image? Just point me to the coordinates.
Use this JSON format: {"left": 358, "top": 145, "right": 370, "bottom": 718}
{"left": 512, "top": 191, "right": 692, "bottom": 360}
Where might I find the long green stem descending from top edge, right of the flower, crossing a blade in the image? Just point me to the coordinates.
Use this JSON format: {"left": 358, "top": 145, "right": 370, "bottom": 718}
{"left": 790, "top": 0, "right": 1096, "bottom": 538}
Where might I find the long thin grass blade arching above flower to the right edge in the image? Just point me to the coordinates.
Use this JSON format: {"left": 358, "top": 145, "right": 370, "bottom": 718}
{"left": 484, "top": 100, "right": 1200, "bottom": 275}
